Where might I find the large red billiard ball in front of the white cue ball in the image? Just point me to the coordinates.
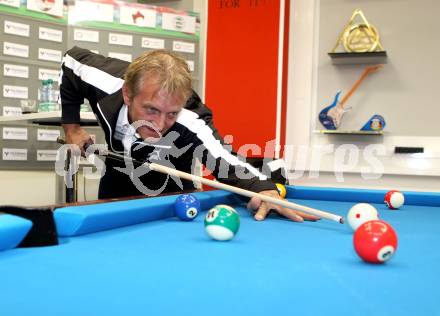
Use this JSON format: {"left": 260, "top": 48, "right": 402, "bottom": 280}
{"left": 353, "top": 220, "right": 397, "bottom": 263}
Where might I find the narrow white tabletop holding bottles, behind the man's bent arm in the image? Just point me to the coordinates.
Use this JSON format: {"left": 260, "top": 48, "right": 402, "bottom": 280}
{"left": 0, "top": 111, "right": 98, "bottom": 126}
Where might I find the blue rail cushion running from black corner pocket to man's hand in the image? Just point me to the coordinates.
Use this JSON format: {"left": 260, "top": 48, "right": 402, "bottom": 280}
{"left": 54, "top": 190, "right": 242, "bottom": 237}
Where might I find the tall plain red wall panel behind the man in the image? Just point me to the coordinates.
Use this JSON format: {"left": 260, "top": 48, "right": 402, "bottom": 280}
{"left": 205, "top": 0, "right": 280, "bottom": 156}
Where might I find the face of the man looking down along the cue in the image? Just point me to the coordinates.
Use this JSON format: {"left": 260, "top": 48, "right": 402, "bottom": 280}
{"left": 122, "top": 79, "right": 184, "bottom": 139}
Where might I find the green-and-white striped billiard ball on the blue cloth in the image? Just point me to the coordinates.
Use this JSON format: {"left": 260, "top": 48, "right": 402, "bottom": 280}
{"left": 205, "top": 204, "right": 240, "bottom": 241}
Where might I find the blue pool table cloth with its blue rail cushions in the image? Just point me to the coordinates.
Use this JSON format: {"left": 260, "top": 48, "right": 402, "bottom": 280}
{"left": 0, "top": 187, "right": 440, "bottom": 316}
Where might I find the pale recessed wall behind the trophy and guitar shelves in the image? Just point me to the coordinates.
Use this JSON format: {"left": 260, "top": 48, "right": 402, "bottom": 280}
{"left": 314, "top": 0, "right": 440, "bottom": 137}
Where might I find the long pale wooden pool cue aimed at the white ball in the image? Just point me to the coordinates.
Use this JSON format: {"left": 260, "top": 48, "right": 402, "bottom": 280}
{"left": 57, "top": 137, "right": 344, "bottom": 224}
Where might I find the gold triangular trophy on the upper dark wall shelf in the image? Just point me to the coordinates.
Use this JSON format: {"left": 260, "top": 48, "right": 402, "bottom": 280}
{"left": 332, "top": 9, "right": 383, "bottom": 53}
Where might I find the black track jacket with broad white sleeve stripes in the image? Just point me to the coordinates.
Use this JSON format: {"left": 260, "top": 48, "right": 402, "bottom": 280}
{"left": 60, "top": 47, "right": 276, "bottom": 192}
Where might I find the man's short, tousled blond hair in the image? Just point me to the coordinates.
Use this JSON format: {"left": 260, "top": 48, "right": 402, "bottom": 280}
{"left": 124, "top": 50, "right": 192, "bottom": 101}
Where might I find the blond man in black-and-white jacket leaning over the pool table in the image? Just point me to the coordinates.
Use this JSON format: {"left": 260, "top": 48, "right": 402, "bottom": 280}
{"left": 60, "top": 47, "right": 318, "bottom": 221}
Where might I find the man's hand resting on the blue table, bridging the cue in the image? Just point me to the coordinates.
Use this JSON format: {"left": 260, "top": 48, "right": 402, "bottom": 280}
{"left": 247, "top": 190, "right": 320, "bottom": 222}
